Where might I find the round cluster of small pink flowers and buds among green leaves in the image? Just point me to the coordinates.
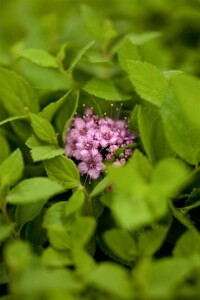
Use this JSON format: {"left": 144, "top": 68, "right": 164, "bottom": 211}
{"left": 65, "top": 108, "right": 136, "bottom": 179}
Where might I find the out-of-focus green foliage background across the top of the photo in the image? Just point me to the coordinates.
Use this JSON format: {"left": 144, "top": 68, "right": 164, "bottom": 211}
{"left": 0, "top": 0, "right": 200, "bottom": 75}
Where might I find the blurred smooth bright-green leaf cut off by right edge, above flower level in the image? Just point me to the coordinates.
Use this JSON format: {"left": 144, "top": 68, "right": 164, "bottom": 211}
{"left": 171, "top": 74, "right": 200, "bottom": 130}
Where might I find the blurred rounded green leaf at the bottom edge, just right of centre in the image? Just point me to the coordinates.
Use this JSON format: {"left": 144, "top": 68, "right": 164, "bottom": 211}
{"left": 89, "top": 262, "right": 134, "bottom": 299}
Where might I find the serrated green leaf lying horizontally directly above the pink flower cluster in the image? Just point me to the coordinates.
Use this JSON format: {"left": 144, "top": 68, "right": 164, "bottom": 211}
{"left": 83, "top": 78, "right": 130, "bottom": 101}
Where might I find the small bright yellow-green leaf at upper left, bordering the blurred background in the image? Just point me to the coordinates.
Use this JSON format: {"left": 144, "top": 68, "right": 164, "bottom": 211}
{"left": 19, "top": 49, "right": 58, "bottom": 68}
